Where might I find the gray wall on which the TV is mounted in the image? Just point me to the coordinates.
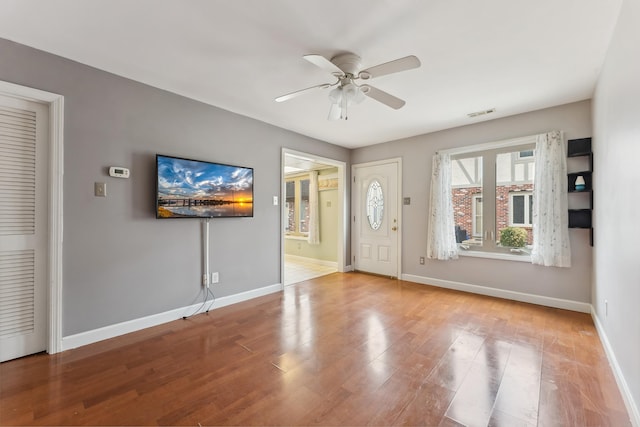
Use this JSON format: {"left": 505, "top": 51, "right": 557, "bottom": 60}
{"left": 0, "top": 39, "right": 350, "bottom": 336}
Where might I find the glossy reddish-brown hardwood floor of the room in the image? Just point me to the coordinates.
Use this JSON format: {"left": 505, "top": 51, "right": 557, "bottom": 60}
{"left": 0, "top": 273, "right": 630, "bottom": 427}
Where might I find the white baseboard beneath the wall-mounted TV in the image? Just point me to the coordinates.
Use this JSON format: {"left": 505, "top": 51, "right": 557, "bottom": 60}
{"left": 62, "top": 283, "right": 283, "bottom": 351}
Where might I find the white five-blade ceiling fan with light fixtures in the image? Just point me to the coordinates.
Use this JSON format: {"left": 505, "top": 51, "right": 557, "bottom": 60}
{"left": 276, "top": 53, "right": 420, "bottom": 120}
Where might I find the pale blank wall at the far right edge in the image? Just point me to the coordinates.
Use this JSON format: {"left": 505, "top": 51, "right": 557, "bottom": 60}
{"left": 592, "top": 0, "right": 640, "bottom": 423}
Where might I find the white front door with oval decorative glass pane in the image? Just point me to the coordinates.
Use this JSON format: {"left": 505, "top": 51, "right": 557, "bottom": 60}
{"left": 353, "top": 160, "right": 400, "bottom": 277}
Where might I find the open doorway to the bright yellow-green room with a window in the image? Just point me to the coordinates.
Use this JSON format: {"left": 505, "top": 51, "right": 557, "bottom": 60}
{"left": 281, "top": 149, "right": 347, "bottom": 286}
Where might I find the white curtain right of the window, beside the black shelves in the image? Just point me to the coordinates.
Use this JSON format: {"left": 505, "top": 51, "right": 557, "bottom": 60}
{"left": 531, "top": 131, "right": 571, "bottom": 267}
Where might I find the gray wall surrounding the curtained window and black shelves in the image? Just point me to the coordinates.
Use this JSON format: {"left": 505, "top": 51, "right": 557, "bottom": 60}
{"left": 351, "top": 101, "right": 592, "bottom": 303}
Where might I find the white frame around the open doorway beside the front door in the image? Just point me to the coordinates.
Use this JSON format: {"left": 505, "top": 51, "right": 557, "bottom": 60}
{"left": 280, "top": 147, "right": 349, "bottom": 289}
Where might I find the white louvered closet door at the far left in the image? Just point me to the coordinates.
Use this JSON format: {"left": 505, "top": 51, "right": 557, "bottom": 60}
{"left": 0, "top": 97, "right": 48, "bottom": 361}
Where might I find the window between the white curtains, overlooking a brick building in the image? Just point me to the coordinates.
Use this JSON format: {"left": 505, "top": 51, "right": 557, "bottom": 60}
{"left": 451, "top": 137, "right": 535, "bottom": 253}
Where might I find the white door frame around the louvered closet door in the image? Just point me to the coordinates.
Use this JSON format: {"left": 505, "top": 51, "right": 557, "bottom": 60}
{"left": 0, "top": 81, "right": 64, "bottom": 354}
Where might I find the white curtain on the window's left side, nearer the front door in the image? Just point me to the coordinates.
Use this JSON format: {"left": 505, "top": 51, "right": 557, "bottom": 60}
{"left": 427, "top": 153, "right": 458, "bottom": 260}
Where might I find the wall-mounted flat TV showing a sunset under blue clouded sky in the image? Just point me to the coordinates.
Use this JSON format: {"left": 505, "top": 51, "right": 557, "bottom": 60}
{"left": 156, "top": 154, "right": 253, "bottom": 218}
